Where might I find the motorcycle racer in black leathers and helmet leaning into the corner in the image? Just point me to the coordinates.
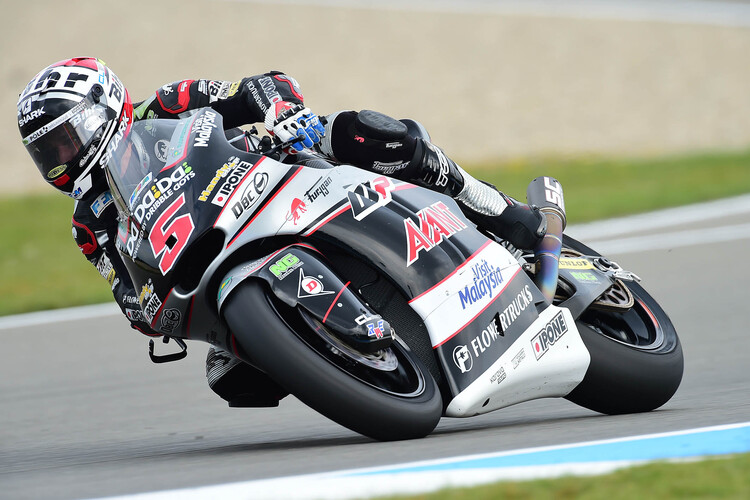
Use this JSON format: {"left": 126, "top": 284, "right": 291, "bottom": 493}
{"left": 18, "top": 57, "right": 545, "bottom": 407}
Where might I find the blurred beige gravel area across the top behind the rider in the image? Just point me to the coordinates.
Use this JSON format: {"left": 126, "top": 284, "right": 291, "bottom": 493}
{"left": 0, "top": 0, "right": 750, "bottom": 196}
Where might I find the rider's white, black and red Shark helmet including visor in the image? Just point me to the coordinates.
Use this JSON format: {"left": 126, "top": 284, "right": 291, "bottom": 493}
{"left": 18, "top": 57, "right": 133, "bottom": 199}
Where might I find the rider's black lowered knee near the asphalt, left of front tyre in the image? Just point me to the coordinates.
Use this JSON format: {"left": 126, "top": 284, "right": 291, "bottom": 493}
{"left": 206, "top": 346, "right": 289, "bottom": 408}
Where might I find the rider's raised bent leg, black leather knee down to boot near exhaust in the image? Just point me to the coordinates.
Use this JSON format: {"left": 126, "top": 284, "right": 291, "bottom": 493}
{"left": 320, "top": 111, "right": 546, "bottom": 249}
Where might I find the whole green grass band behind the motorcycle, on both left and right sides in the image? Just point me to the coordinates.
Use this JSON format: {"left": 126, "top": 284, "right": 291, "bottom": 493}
{"left": 0, "top": 146, "right": 750, "bottom": 315}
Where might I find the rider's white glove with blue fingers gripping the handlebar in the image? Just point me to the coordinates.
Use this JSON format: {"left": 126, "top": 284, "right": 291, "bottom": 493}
{"left": 265, "top": 101, "right": 325, "bottom": 154}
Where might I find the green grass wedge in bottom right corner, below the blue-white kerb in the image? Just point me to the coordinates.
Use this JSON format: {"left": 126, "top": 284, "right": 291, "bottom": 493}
{"left": 387, "top": 454, "right": 750, "bottom": 500}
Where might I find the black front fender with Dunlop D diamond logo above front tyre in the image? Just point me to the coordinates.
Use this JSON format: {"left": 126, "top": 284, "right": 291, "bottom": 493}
{"left": 217, "top": 244, "right": 393, "bottom": 353}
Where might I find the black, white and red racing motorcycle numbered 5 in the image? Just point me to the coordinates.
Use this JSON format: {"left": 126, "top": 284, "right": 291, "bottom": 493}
{"left": 106, "top": 109, "right": 683, "bottom": 440}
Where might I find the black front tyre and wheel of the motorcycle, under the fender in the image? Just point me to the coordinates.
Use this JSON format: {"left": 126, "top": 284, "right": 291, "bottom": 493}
{"left": 224, "top": 280, "right": 443, "bottom": 441}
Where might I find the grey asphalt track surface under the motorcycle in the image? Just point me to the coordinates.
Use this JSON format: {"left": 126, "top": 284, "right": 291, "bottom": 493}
{"left": 0, "top": 199, "right": 750, "bottom": 499}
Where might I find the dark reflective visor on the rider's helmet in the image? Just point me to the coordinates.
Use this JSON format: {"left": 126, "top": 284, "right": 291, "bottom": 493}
{"left": 23, "top": 90, "right": 114, "bottom": 182}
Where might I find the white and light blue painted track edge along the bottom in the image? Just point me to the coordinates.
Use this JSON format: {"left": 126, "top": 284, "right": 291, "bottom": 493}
{"left": 94, "top": 422, "right": 750, "bottom": 500}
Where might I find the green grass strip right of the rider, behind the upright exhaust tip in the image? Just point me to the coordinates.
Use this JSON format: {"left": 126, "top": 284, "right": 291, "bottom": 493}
{"left": 471, "top": 151, "right": 750, "bottom": 224}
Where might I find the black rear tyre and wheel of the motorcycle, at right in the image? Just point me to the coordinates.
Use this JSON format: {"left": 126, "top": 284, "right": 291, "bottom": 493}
{"left": 563, "top": 236, "right": 683, "bottom": 414}
